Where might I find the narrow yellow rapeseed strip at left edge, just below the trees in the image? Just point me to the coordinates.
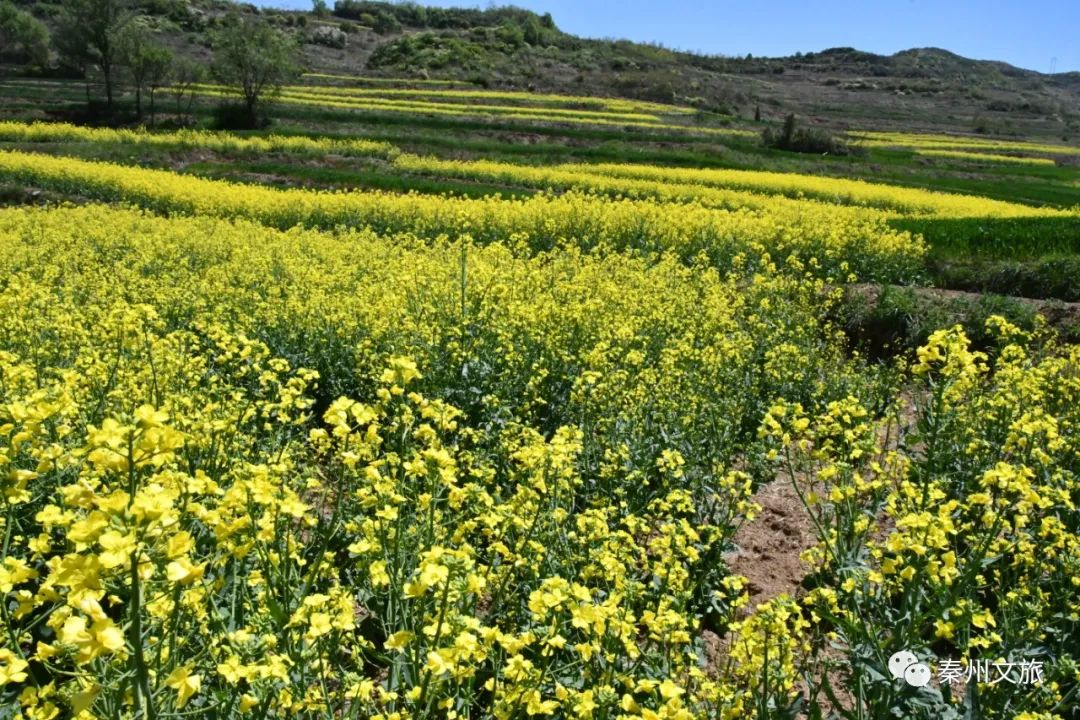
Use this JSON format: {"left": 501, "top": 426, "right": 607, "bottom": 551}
{"left": 0, "top": 121, "right": 399, "bottom": 158}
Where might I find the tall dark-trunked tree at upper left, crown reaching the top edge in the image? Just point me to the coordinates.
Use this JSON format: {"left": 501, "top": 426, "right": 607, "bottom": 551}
{"left": 57, "top": 0, "right": 135, "bottom": 110}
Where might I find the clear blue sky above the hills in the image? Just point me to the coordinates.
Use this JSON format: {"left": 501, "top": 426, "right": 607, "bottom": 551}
{"left": 247, "top": 0, "right": 1080, "bottom": 72}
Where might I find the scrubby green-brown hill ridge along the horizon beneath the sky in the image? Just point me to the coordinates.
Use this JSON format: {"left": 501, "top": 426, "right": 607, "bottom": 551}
{"left": 8, "top": 0, "right": 1080, "bottom": 140}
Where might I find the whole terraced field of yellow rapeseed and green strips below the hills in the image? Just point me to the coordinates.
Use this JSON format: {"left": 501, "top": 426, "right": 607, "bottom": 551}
{"left": 0, "top": 69, "right": 1080, "bottom": 720}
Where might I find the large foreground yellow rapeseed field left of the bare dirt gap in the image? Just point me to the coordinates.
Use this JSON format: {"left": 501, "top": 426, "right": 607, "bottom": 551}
{"left": 0, "top": 206, "right": 873, "bottom": 720}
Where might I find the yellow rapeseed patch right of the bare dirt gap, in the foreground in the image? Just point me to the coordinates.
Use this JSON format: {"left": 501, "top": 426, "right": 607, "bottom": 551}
{"left": 760, "top": 316, "right": 1080, "bottom": 719}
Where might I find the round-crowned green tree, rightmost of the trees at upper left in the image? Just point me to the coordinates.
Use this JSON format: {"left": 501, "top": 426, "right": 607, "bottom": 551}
{"left": 213, "top": 16, "right": 299, "bottom": 125}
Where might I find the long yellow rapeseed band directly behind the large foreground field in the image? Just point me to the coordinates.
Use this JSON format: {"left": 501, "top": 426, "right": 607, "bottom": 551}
{"left": 0, "top": 147, "right": 926, "bottom": 281}
